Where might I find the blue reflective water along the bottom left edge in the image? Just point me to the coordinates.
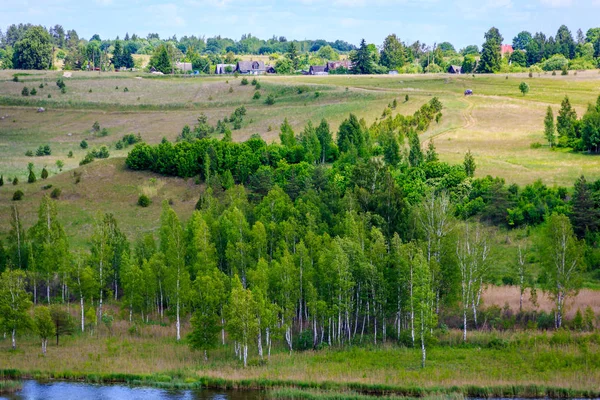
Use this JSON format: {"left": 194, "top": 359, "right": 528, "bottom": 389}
{"left": 0, "top": 380, "right": 265, "bottom": 400}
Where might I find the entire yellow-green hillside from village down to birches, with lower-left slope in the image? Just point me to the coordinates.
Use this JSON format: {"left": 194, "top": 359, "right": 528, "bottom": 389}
{"left": 0, "top": 71, "right": 600, "bottom": 244}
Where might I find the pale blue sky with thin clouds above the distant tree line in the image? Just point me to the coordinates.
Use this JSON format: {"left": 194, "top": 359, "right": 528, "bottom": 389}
{"left": 0, "top": 0, "right": 600, "bottom": 49}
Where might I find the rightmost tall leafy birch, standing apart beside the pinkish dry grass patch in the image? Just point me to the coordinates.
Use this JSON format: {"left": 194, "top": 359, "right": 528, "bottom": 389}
{"left": 540, "top": 214, "right": 584, "bottom": 329}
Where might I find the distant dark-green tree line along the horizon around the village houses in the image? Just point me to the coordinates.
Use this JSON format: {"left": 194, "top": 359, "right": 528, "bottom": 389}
{"left": 0, "top": 24, "right": 600, "bottom": 74}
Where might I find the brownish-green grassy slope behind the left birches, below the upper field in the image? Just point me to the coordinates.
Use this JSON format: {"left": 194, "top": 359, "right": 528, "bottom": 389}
{"left": 0, "top": 158, "right": 201, "bottom": 249}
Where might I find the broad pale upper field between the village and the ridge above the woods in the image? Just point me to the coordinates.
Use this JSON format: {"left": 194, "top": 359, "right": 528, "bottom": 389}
{"left": 0, "top": 71, "right": 600, "bottom": 185}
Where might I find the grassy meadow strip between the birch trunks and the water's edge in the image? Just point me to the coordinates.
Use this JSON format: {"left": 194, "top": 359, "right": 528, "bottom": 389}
{"left": 0, "top": 321, "right": 600, "bottom": 391}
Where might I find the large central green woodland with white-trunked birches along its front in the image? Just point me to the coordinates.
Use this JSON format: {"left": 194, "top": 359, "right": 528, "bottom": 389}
{"left": 0, "top": 98, "right": 600, "bottom": 364}
